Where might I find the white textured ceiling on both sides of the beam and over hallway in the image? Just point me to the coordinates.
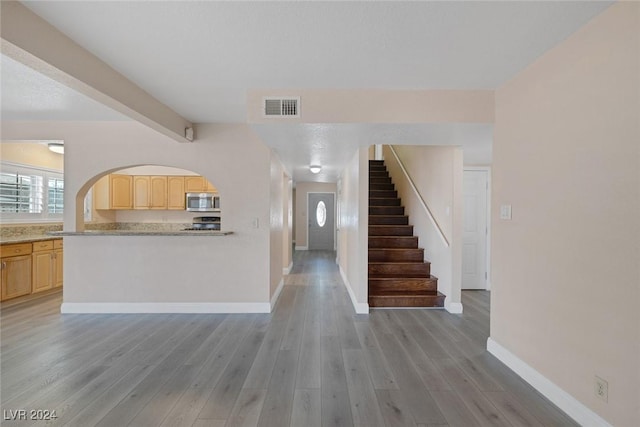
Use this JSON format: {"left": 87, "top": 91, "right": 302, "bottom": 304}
{"left": 2, "top": 1, "right": 612, "bottom": 180}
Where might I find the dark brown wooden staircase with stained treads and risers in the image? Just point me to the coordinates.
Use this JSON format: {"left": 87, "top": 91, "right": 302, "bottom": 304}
{"left": 369, "top": 160, "right": 445, "bottom": 307}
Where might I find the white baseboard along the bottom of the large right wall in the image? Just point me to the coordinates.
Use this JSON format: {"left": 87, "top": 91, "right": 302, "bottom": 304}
{"left": 487, "top": 337, "right": 612, "bottom": 427}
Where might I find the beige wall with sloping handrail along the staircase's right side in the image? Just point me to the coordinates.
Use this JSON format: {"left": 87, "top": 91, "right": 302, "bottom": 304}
{"left": 383, "top": 145, "right": 462, "bottom": 312}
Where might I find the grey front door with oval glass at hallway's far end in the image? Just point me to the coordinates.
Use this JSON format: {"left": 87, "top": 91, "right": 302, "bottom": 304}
{"left": 307, "top": 193, "right": 335, "bottom": 251}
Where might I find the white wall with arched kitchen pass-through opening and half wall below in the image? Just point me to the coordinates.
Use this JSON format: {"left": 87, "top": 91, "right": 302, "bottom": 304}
{"left": 2, "top": 122, "right": 282, "bottom": 311}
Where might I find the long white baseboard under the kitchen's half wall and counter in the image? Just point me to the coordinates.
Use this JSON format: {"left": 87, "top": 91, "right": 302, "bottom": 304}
{"left": 60, "top": 302, "right": 271, "bottom": 314}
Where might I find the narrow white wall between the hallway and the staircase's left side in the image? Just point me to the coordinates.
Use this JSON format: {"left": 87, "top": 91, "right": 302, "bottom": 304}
{"left": 337, "top": 147, "right": 369, "bottom": 313}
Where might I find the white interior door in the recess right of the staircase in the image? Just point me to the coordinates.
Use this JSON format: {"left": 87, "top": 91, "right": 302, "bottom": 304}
{"left": 462, "top": 170, "right": 489, "bottom": 289}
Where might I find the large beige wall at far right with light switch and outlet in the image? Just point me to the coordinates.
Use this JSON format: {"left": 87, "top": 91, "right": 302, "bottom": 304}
{"left": 491, "top": 2, "right": 640, "bottom": 426}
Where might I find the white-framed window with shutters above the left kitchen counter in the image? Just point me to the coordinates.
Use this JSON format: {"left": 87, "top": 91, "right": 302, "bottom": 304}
{"left": 0, "top": 162, "right": 64, "bottom": 222}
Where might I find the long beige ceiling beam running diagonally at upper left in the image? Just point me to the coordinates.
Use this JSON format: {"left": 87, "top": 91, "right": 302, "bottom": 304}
{"left": 0, "top": 1, "right": 194, "bottom": 142}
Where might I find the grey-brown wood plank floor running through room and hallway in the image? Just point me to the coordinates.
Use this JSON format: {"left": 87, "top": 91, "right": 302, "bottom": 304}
{"left": 0, "top": 251, "right": 577, "bottom": 427}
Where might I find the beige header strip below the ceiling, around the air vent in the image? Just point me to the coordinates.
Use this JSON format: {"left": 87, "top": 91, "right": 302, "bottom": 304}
{"left": 247, "top": 89, "right": 494, "bottom": 123}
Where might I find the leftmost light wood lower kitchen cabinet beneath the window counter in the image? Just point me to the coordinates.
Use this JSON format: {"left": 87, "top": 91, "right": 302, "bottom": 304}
{"left": 0, "top": 243, "right": 32, "bottom": 301}
